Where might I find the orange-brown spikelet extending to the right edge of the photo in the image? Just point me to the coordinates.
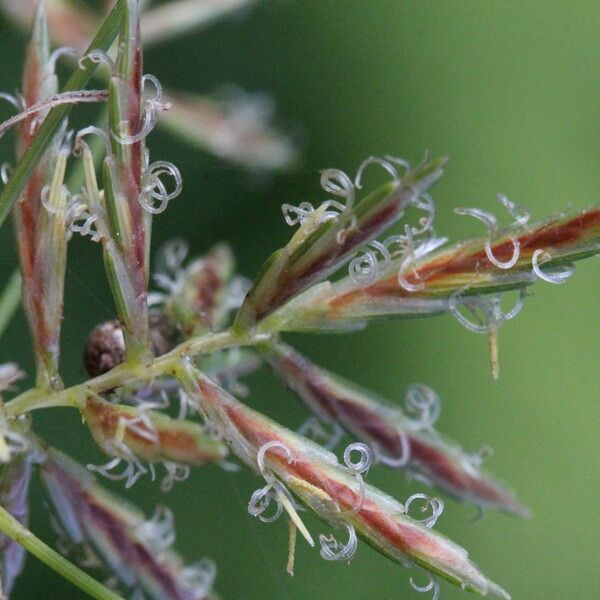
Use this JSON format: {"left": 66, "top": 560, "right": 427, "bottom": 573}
{"left": 262, "top": 208, "right": 600, "bottom": 332}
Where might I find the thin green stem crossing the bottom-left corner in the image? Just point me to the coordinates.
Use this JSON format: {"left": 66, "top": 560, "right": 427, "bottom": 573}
{"left": 0, "top": 506, "right": 123, "bottom": 600}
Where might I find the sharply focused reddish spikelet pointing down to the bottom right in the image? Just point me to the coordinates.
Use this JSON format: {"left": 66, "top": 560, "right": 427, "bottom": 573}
{"left": 180, "top": 365, "right": 510, "bottom": 599}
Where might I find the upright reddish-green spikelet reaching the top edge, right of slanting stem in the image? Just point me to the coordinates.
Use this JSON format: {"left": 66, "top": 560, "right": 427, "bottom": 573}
{"left": 103, "top": 0, "right": 151, "bottom": 360}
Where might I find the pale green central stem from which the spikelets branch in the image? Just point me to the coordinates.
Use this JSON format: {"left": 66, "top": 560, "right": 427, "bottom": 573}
{"left": 4, "top": 330, "right": 268, "bottom": 417}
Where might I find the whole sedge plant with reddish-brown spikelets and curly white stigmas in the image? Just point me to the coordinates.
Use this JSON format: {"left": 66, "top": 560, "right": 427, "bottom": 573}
{"left": 0, "top": 0, "right": 600, "bottom": 600}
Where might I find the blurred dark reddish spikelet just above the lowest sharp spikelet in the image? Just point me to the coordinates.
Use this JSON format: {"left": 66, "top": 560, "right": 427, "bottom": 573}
{"left": 265, "top": 343, "right": 528, "bottom": 516}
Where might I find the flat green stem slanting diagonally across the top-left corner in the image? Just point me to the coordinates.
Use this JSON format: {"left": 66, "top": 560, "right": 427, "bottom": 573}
{"left": 0, "top": 0, "right": 126, "bottom": 227}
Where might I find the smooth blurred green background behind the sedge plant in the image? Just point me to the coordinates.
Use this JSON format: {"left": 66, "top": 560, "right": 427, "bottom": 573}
{"left": 0, "top": 0, "right": 600, "bottom": 600}
